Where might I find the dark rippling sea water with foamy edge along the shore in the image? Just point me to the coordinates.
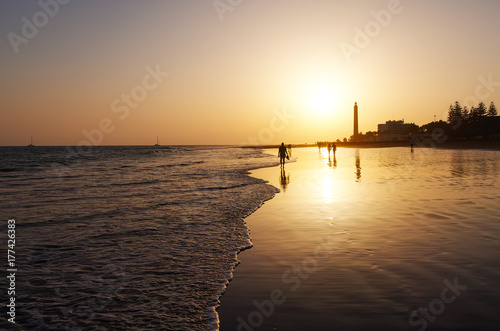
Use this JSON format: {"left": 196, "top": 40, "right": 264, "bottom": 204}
{"left": 0, "top": 146, "right": 278, "bottom": 330}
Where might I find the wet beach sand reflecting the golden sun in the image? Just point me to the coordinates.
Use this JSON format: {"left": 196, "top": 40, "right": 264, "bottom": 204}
{"left": 218, "top": 148, "right": 500, "bottom": 331}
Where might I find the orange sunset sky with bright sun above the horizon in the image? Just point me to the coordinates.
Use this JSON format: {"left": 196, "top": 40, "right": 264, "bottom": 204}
{"left": 0, "top": 0, "right": 500, "bottom": 146}
